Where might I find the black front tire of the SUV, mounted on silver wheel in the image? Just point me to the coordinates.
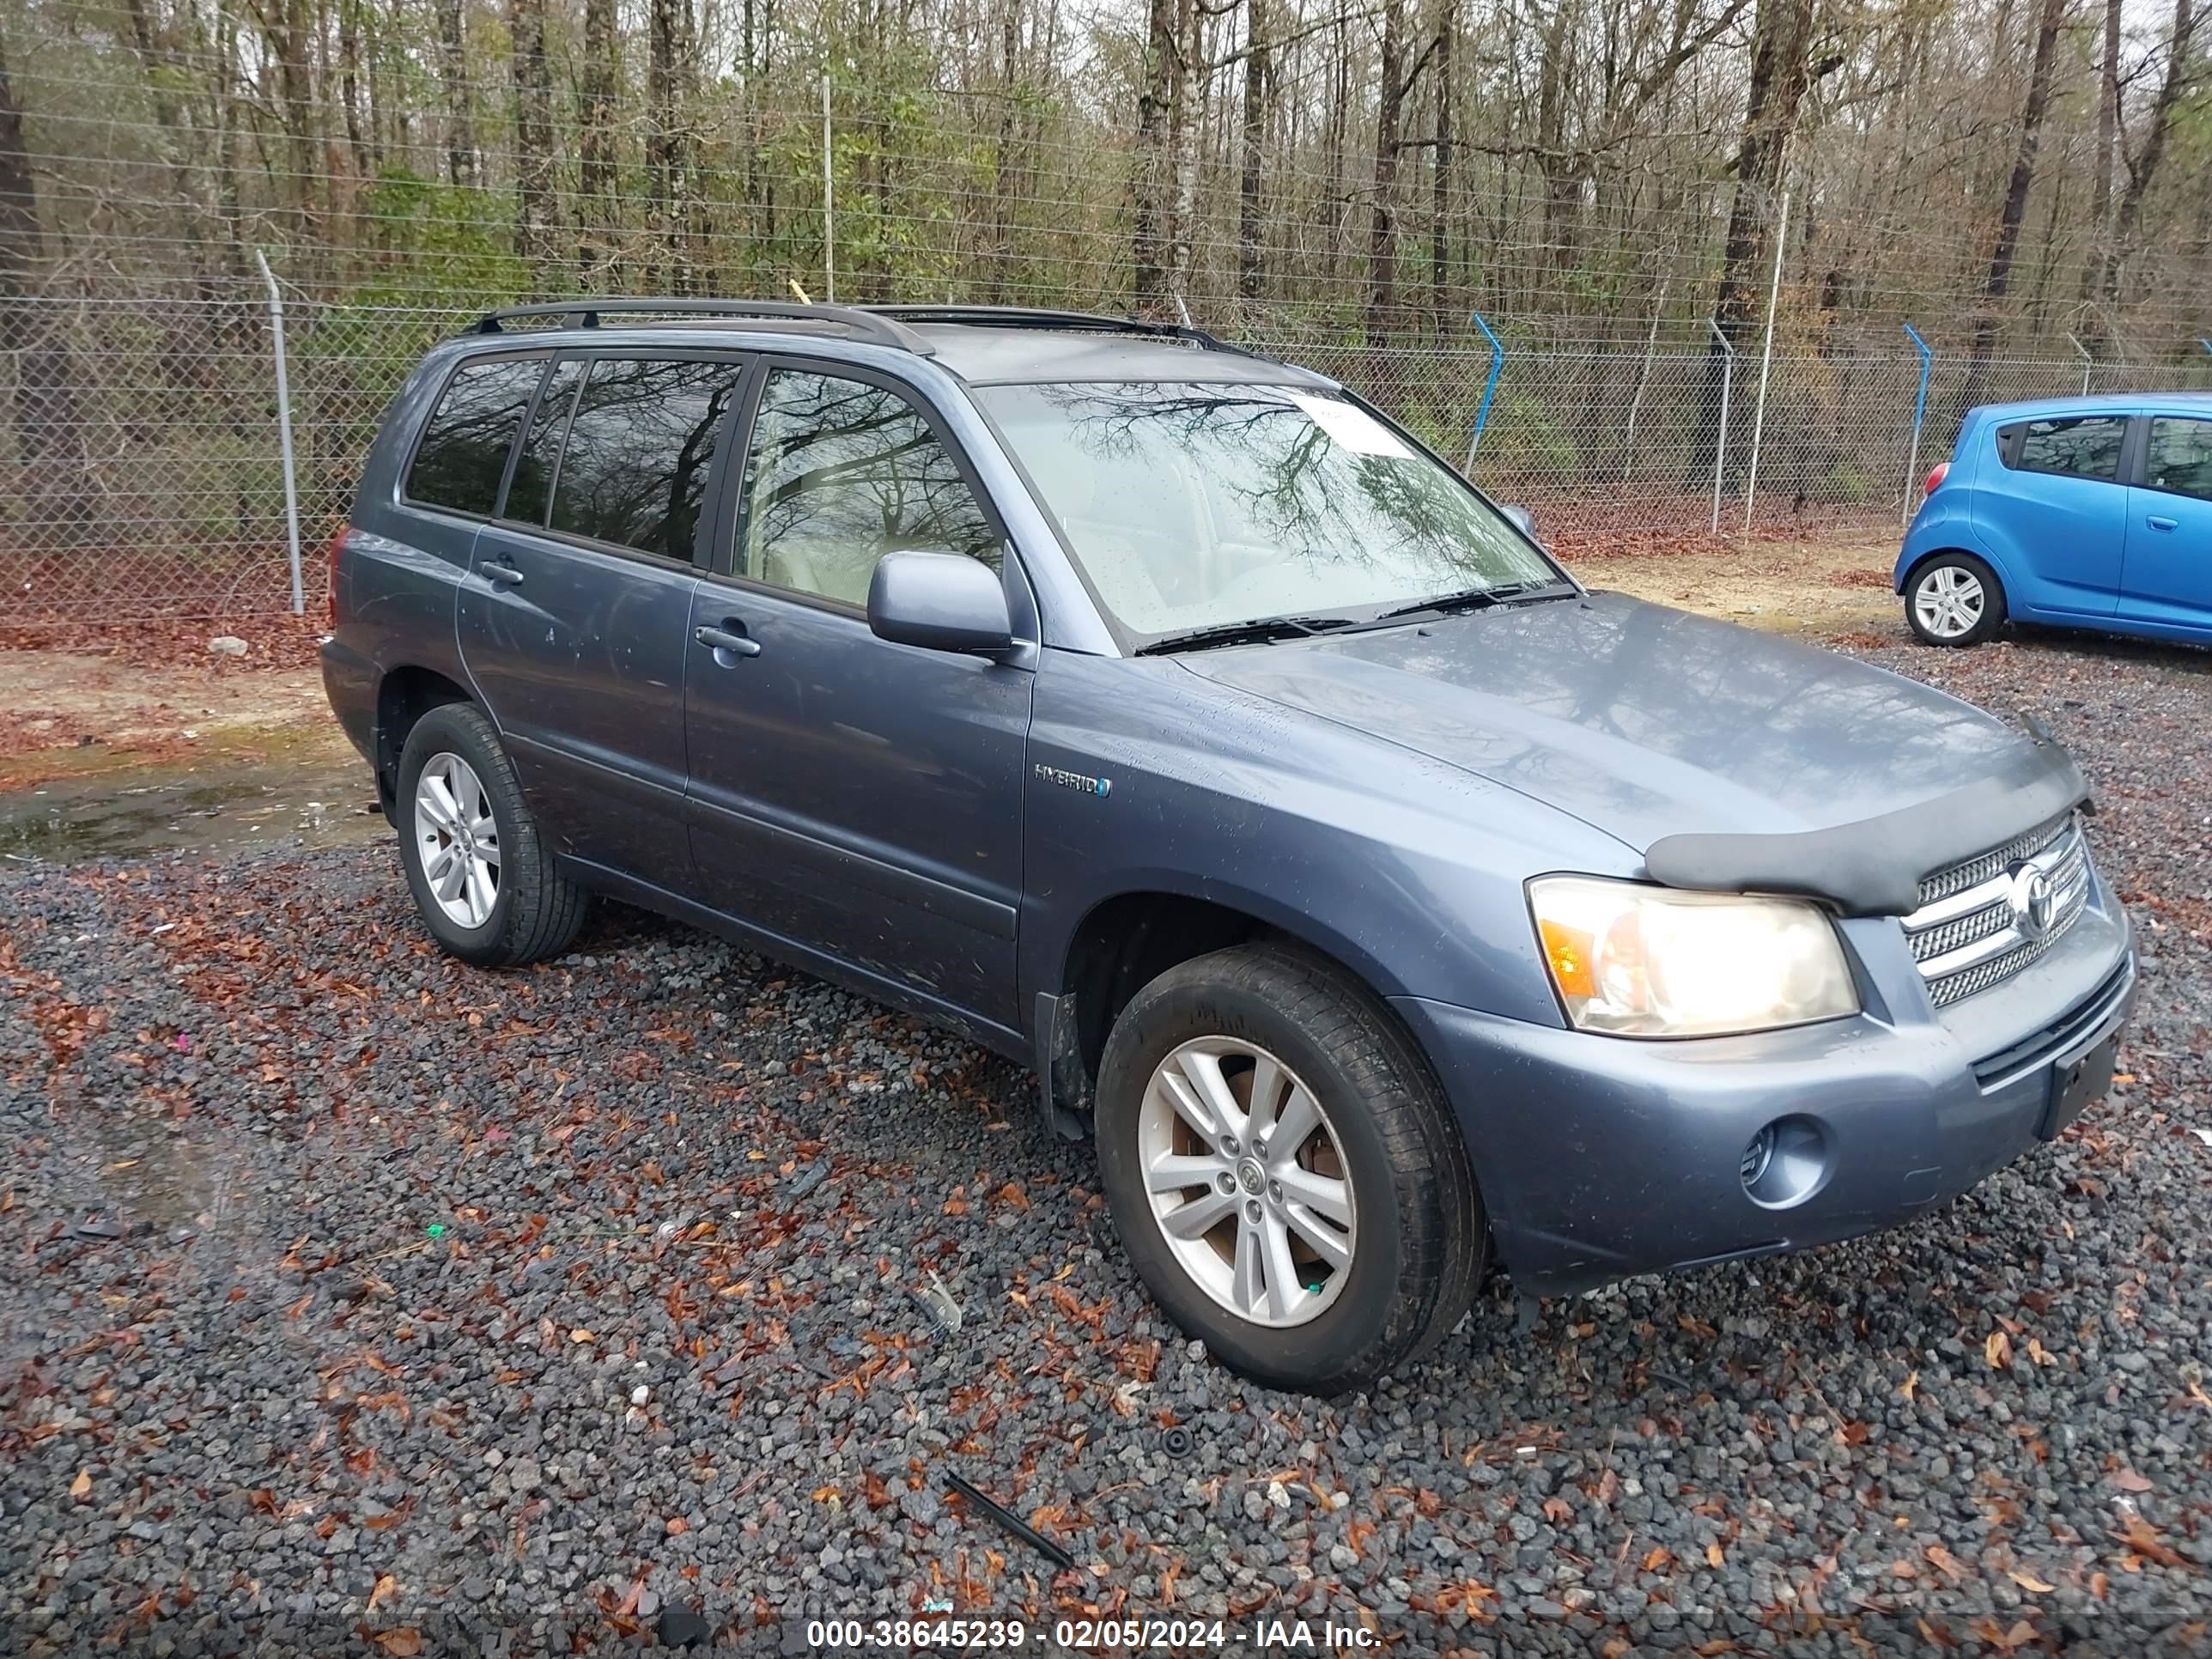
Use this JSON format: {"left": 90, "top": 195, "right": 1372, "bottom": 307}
{"left": 1095, "top": 942, "right": 1489, "bottom": 1395}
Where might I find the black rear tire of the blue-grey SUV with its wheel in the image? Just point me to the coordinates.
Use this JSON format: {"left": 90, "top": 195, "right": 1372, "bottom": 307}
{"left": 394, "top": 703, "right": 588, "bottom": 967}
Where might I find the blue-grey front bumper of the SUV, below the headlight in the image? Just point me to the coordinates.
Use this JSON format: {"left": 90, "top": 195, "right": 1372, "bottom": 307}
{"left": 1394, "top": 878, "right": 2135, "bottom": 1294}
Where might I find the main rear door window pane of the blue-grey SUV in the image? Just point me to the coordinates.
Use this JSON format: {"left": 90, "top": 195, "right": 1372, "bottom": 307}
{"left": 553, "top": 358, "right": 745, "bottom": 560}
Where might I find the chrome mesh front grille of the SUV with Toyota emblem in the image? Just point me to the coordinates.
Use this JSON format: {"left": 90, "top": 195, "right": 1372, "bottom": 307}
{"left": 1905, "top": 811, "right": 2090, "bottom": 1009}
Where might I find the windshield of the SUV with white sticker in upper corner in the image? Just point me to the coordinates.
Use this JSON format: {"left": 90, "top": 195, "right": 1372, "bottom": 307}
{"left": 975, "top": 383, "right": 1559, "bottom": 639}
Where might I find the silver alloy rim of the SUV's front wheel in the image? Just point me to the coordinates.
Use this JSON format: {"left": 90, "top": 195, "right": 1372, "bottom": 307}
{"left": 1137, "top": 1037, "right": 1358, "bottom": 1328}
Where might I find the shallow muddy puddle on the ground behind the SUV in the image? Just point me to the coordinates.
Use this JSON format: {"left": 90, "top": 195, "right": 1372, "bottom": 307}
{"left": 0, "top": 750, "right": 392, "bottom": 863}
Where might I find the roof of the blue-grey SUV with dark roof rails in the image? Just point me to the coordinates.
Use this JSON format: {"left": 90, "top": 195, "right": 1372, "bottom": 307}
{"left": 448, "top": 301, "right": 1336, "bottom": 389}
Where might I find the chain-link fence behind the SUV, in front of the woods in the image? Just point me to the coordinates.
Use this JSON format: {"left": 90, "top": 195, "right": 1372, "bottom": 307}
{"left": 0, "top": 292, "right": 2212, "bottom": 629}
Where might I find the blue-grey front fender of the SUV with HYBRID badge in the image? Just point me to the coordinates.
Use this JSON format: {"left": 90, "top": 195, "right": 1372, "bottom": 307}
{"left": 1018, "top": 653, "right": 1641, "bottom": 1024}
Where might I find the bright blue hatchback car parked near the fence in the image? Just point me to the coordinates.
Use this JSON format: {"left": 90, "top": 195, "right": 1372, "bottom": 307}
{"left": 1893, "top": 392, "right": 2212, "bottom": 646}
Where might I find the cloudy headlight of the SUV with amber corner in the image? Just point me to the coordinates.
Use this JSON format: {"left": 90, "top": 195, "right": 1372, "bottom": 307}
{"left": 1528, "top": 876, "right": 1858, "bottom": 1037}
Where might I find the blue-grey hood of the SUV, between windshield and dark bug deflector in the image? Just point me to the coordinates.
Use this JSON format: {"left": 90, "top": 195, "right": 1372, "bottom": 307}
{"left": 1179, "top": 592, "right": 2028, "bottom": 852}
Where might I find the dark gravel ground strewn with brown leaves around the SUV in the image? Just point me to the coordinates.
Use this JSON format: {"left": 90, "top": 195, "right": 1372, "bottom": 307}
{"left": 0, "top": 641, "right": 2212, "bottom": 1659}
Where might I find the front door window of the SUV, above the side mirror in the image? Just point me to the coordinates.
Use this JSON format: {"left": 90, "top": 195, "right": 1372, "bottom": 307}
{"left": 737, "top": 369, "right": 1002, "bottom": 604}
